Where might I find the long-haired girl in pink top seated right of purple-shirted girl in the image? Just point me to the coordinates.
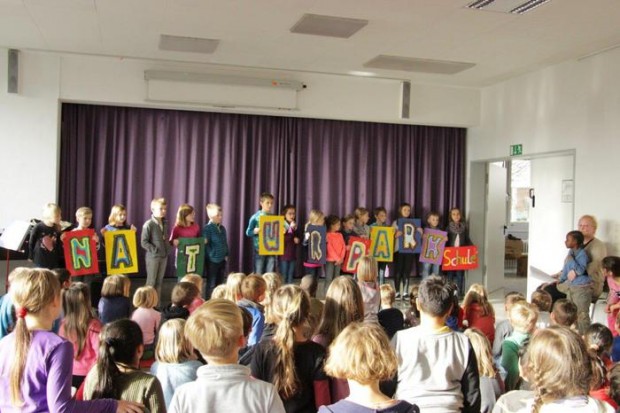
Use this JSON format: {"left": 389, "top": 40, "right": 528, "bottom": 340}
{"left": 58, "top": 282, "right": 101, "bottom": 389}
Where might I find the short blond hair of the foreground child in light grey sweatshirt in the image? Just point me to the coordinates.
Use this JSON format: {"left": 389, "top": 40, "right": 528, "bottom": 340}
{"left": 185, "top": 298, "right": 244, "bottom": 362}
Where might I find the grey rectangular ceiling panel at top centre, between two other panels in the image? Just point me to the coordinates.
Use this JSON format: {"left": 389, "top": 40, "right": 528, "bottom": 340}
{"left": 291, "top": 14, "right": 368, "bottom": 39}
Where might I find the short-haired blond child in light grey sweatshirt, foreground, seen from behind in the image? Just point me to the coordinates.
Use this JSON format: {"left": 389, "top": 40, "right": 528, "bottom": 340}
{"left": 168, "top": 298, "right": 284, "bottom": 413}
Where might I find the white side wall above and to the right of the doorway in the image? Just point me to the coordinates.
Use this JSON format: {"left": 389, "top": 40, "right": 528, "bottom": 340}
{"left": 468, "top": 49, "right": 620, "bottom": 253}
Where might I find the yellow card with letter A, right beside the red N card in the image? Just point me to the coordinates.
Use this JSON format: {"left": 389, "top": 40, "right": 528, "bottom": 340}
{"left": 105, "top": 229, "right": 138, "bottom": 275}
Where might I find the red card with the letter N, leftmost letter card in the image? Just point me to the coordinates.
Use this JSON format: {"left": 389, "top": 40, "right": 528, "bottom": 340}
{"left": 63, "top": 229, "right": 99, "bottom": 276}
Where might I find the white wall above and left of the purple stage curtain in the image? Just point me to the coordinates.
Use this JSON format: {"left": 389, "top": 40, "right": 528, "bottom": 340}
{"left": 0, "top": 48, "right": 480, "bottom": 229}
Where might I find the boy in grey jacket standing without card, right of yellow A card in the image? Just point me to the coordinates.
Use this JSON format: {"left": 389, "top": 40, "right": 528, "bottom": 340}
{"left": 140, "top": 198, "right": 171, "bottom": 297}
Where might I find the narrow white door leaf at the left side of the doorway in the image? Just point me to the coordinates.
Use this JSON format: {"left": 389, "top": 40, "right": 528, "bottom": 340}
{"left": 484, "top": 164, "right": 507, "bottom": 294}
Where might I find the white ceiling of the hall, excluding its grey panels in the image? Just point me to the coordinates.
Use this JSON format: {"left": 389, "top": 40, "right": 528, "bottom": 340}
{"left": 0, "top": 0, "right": 620, "bottom": 86}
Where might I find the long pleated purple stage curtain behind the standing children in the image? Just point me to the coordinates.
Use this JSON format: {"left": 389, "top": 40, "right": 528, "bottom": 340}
{"left": 58, "top": 103, "right": 466, "bottom": 273}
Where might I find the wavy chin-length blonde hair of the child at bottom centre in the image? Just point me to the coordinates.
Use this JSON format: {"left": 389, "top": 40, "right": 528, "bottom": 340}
{"left": 325, "top": 322, "right": 398, "bottom": 384}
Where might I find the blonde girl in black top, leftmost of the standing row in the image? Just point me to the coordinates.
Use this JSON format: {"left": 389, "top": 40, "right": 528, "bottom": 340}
{"left": 28, "top": 203, "right": 64, "bottom": 270}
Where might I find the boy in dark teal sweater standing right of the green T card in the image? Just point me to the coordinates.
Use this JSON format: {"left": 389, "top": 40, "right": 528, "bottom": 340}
{"left": 202, "top": 204, "right": 228, "bottom": 298}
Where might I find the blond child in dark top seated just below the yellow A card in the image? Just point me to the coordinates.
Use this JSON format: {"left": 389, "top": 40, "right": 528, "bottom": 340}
{"left": 97, "top": 274, "right": 131, "bottom": 324}
